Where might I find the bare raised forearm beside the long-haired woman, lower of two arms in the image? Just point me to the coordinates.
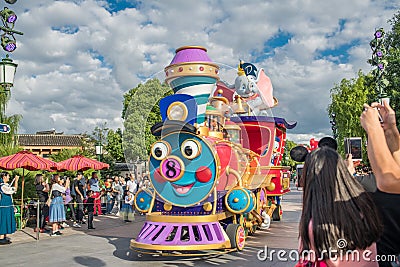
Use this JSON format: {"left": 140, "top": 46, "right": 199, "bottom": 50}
{"left": 360, "top": 104, "right": 400, "bottom": 193}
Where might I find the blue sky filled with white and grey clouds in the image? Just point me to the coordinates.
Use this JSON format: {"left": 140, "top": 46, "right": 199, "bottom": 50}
{"left": 2, "top": 0, "right": 400, "bottom": 142}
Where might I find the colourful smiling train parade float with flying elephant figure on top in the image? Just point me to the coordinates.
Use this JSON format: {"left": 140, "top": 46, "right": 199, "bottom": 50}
{"left": 130, "top": 46, "right": 296, "bottom": 254}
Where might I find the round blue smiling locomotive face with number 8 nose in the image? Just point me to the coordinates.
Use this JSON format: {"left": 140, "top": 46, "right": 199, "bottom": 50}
{"left": 150, "top": 132, "right": 218, "bottom": 207}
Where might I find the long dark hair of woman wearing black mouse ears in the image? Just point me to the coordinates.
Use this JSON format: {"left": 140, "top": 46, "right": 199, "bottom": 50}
{"left": 299, "top": 147, "right": 382, "bottom": 258}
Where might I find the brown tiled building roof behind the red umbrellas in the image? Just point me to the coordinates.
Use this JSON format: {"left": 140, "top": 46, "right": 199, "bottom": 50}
{"left": 17, "top": 134, "right": 82, "bottom": 147}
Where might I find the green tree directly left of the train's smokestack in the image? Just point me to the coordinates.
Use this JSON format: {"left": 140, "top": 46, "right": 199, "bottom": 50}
{"left": 122, "top": 79, "right": 172, "bottom": 162}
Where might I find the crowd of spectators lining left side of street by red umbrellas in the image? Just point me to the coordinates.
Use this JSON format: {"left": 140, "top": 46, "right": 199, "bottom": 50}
{"left": 0, "top": 171, "right": 149, "bottom": 245}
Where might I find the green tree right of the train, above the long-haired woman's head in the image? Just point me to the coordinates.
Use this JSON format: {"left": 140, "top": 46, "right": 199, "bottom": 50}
{"left": 328, "top": 71, "right": 376, "bottom": 159}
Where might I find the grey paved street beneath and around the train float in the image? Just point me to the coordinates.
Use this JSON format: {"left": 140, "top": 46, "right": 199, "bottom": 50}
{"left": 0, "top": 188, "right": 302, "bottom": 267}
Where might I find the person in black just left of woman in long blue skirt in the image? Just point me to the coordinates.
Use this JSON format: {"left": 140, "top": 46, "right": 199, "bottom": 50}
{"left": 35, "top": 174, "right": 50, "bottom": 233}
